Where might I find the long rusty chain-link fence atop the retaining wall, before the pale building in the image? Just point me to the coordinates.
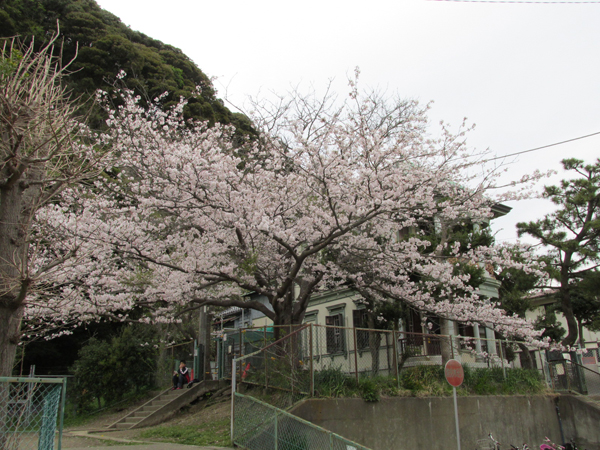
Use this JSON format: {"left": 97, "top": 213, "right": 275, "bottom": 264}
{"left": 226, "top": 324, "right": 543, "bottom": 409}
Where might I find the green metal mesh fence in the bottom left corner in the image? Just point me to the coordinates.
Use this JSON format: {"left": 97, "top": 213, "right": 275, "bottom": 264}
{"left": 0, "top": 377, "right": 66, "bottom": 450}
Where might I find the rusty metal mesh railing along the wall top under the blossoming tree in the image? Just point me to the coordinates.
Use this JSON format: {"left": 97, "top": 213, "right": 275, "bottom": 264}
{"left": 223, "top": 324, "right": 541, "bottom": 388}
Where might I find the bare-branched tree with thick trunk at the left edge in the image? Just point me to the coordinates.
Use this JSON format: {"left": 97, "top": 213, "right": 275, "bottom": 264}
{"left": 0, "top": 33, "right": 110, "bottom": 376}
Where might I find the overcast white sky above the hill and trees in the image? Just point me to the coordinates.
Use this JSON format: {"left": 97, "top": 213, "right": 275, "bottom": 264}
{"left": 97, "top": 0, "right": 600, "bottom": 242}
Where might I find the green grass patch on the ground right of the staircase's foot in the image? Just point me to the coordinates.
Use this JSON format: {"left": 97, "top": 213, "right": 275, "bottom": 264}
{"left": 140, "top": 418, "right": 232, "bottom": 447}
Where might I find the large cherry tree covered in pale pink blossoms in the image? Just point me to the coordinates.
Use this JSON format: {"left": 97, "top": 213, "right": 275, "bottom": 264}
{"left": 31, "top": 75, "right": 548, "bottom": 354}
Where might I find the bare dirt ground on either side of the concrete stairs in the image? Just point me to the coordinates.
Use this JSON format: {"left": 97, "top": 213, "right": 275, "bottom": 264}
{"left": 62, "top": 399, "right": 231, "bottom": 448}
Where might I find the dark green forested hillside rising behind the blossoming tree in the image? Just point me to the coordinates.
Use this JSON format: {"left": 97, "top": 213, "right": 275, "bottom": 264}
{"left": 0, "top": 0, "right": 251, "bottom": 132}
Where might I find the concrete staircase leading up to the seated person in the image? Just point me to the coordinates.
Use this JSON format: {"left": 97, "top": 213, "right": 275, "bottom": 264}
{"left": 107, "top": 380, "right": 226, "bottom": 430}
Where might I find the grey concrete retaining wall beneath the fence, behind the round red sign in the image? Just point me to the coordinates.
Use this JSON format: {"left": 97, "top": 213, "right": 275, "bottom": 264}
{"left": 292, "top": 396, "right": 600, "bottom": 450}
